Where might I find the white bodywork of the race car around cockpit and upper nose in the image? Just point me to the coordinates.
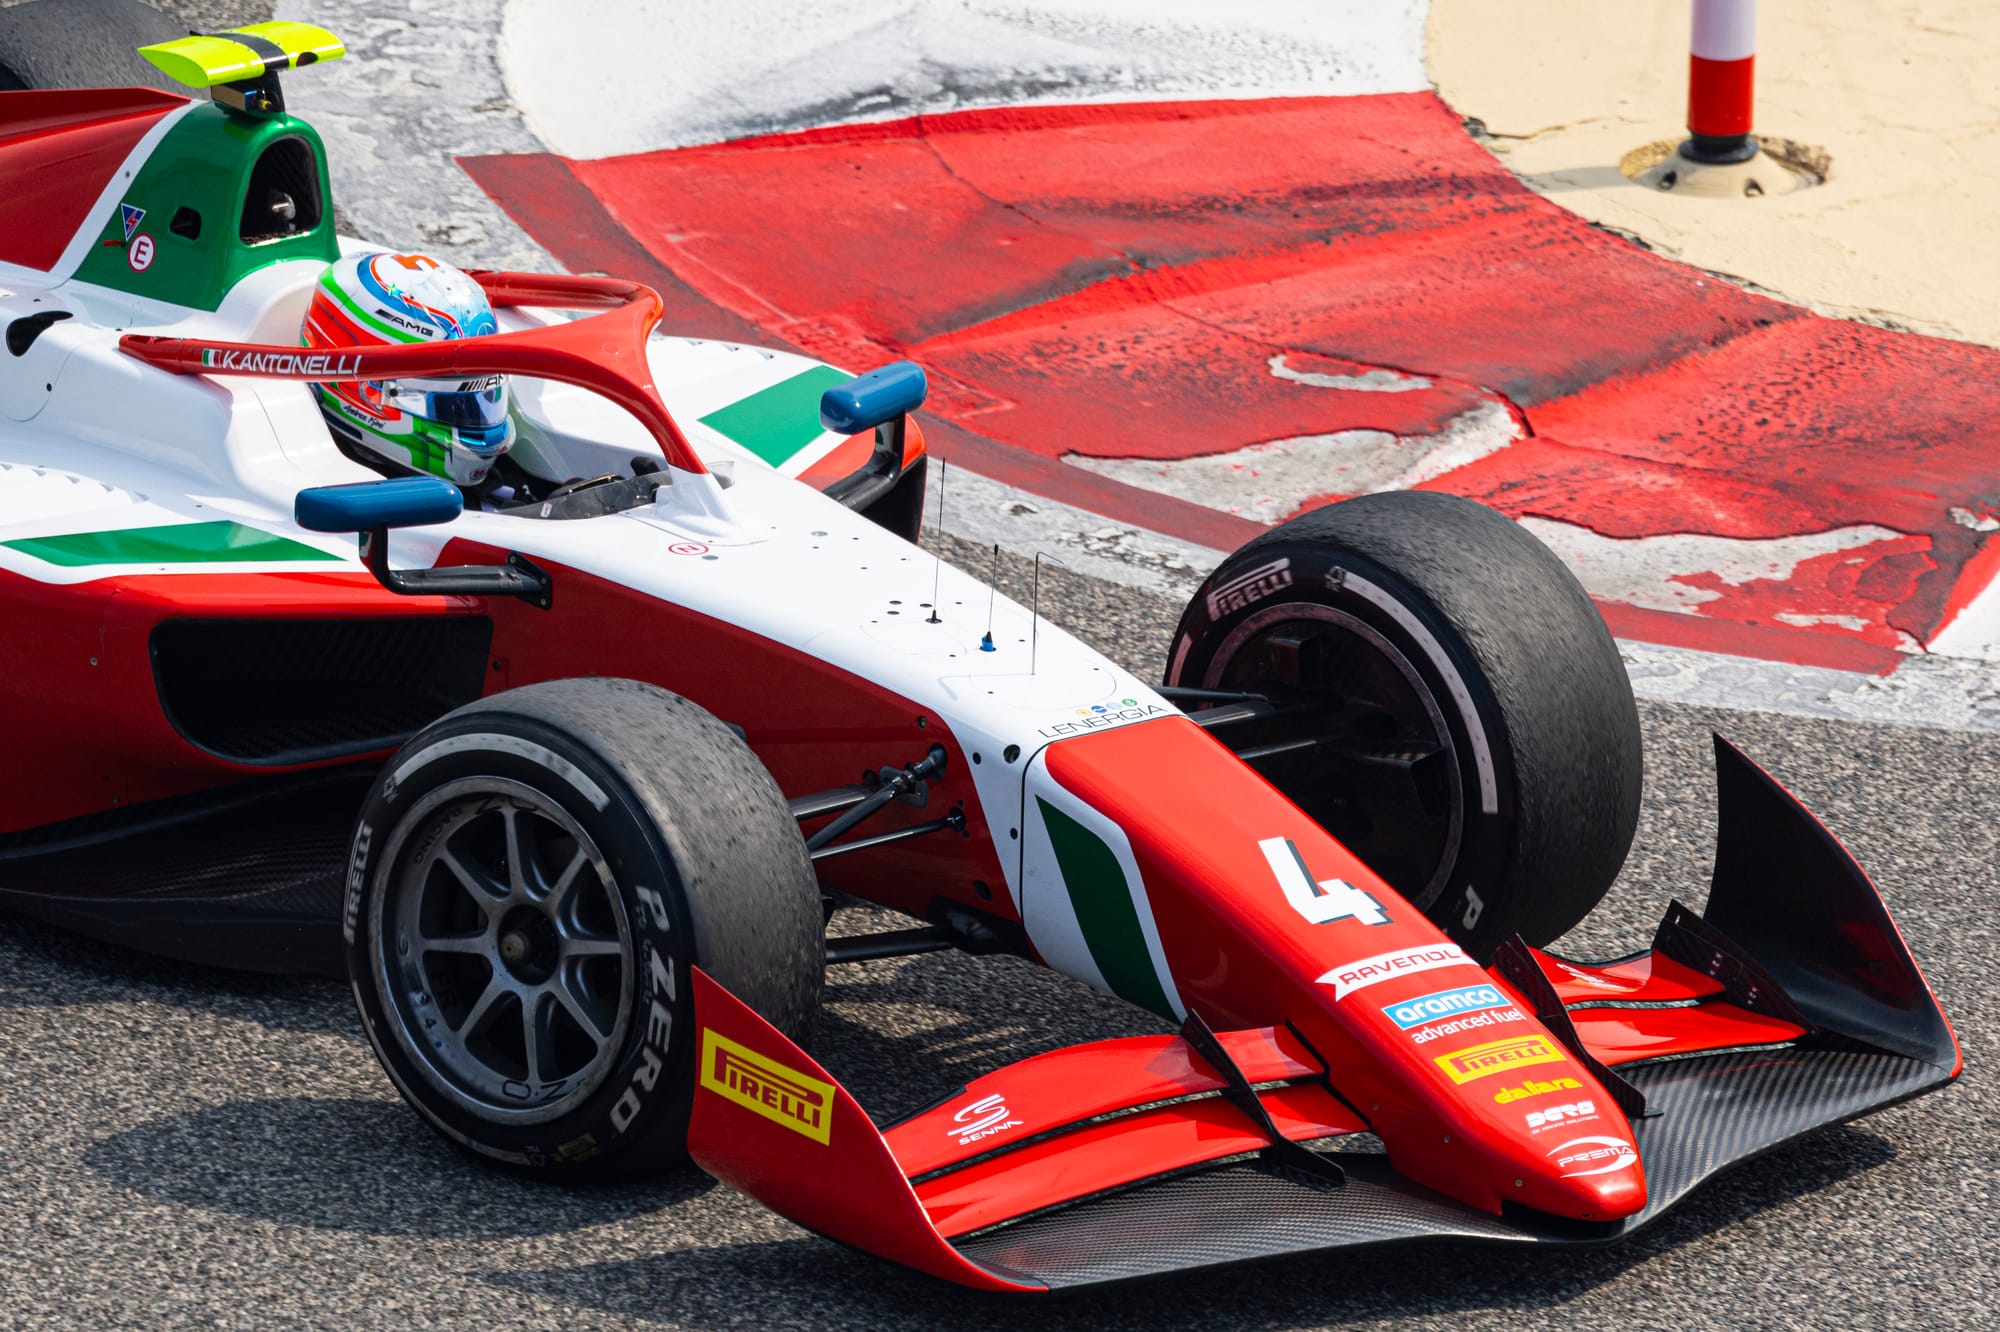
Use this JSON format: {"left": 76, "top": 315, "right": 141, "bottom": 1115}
{"left": 0, "top": 244, "right": 1172, "bottom": 900}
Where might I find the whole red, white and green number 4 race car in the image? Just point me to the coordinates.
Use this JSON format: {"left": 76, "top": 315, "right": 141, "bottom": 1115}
{"left": 0, "top": 22, "right": 1962, "bottom": 1294}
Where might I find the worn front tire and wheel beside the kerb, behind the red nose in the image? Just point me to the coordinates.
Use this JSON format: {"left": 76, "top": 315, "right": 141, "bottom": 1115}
{"left": 1166, "top": 492, "right": 1642, "bottom": 960}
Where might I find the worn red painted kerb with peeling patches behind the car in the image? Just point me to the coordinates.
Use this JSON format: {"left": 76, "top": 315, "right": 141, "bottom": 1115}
{"left": 464, "top": 94, "right": 2000, "bottom": 672}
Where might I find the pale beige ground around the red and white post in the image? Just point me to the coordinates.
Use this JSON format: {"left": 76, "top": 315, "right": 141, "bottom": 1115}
{"left": 1428, "top": 0, "right": 2000, "bottom": 346}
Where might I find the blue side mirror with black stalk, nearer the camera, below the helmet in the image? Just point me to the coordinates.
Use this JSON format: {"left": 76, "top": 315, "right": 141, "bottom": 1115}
{"left": 292, "top": 476, "right": 552, "bottom": 610}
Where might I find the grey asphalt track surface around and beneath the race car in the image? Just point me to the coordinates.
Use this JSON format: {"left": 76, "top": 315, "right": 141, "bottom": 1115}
{"left": 0, "top": 538, "right": 2000, "bottom": 1332}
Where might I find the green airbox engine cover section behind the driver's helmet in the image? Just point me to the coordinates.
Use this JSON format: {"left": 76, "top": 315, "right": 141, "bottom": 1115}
{"left": 76, "top": 102, "right": 340, "bottom": 310}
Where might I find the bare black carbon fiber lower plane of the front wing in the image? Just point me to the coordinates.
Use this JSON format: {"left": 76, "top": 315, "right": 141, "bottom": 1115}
{"left": 958, "top": 1044, "right": 1948, "bottom": 1288}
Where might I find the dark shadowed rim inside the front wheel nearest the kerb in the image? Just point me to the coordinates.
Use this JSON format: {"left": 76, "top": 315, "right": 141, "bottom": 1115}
{"left": 1202, "top": 602, "right": 1466, "bottom": 910}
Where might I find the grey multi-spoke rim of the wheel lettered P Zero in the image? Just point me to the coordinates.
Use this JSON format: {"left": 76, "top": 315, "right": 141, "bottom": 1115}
{"left": 372, "top": 778, "right": 634, "bottom": 1124}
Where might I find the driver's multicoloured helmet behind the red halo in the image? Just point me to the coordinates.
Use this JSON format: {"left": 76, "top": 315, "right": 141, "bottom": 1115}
{"left": 300, "top": 254, "right": 514, "bottom": 486}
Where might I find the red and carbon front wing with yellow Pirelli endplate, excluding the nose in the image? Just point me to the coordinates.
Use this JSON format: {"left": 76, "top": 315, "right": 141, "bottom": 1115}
{"left": 688, "top": 738, "right": 1962, "bottom": 1294}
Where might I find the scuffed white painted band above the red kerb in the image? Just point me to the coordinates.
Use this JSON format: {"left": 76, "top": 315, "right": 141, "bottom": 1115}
{"left": 502, "top": 0, "right": 1430, "bottom": 158}
